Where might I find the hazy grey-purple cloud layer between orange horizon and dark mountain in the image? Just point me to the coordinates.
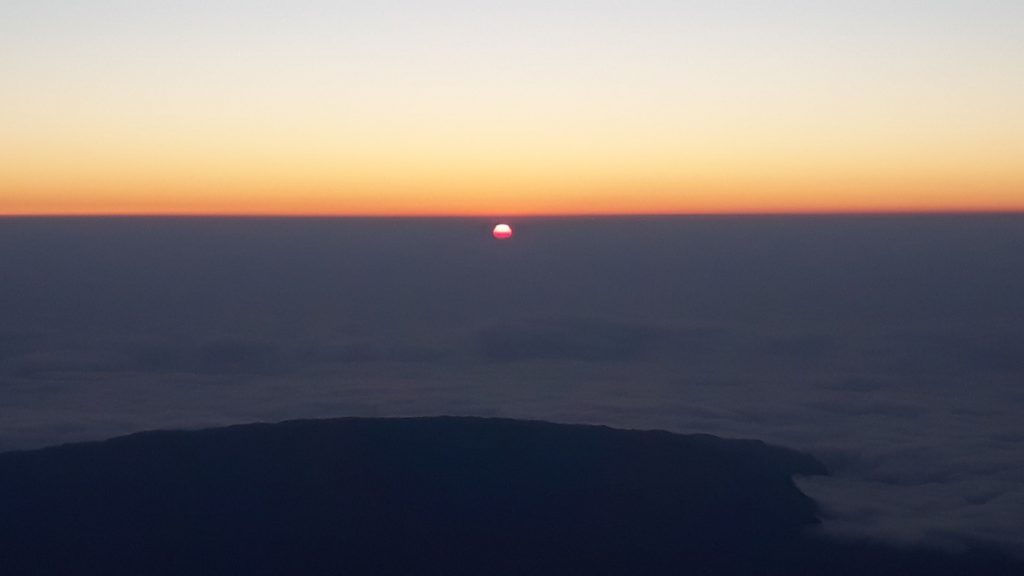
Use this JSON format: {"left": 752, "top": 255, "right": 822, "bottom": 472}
{"left": 0, "top": 215, "right": 1024, "bottom": 553}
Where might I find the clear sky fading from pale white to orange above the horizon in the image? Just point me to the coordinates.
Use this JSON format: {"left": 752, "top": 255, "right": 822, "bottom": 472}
{"left": 0, "top": 0, "right": 1024, "bottom": 215}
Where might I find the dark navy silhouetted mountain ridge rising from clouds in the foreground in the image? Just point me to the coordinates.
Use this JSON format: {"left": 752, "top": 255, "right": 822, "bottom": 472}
{"left": 0, "top": 418, "right": 1024, "bottom": 576}
